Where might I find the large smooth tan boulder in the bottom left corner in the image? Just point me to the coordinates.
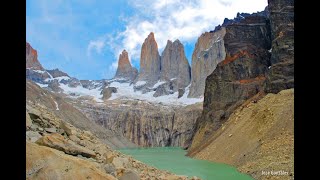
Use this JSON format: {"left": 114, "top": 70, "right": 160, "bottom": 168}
{"left": 26, "top": 142, "right": 116, "bottom": 180}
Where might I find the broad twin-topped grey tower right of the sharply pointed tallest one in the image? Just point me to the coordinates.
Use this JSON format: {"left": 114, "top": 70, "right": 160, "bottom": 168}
{"left": 160, "top": 40, "right": 191, "bottom": 89}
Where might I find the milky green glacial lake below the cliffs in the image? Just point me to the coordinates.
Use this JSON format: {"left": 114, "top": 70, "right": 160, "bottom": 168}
{"left": 118, "top": 147, "right": 252, "bottom": 180}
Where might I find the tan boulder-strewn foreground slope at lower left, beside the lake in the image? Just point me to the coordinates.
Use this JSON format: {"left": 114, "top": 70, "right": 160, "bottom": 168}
{"left": 26, "top": 100, "right": 200, "bottom": 180}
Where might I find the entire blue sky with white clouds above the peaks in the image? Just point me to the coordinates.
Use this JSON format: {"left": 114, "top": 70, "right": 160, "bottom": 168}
{"left": 26, "top": 0, "right": 267, "bottom": 80}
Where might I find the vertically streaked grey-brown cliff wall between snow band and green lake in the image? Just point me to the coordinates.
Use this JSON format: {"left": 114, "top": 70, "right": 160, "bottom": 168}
{"left": 75, "top": 100, "right": 202, "bottom": 147}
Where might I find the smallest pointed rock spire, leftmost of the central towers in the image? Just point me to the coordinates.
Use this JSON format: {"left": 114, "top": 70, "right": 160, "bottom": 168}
{"left": 114, "top": 50, "right": 138, "bottom": 81}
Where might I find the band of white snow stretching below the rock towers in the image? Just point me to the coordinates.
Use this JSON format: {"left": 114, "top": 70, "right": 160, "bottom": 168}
{"left": 27, "top": 69, "right": 203, "bottom": 106}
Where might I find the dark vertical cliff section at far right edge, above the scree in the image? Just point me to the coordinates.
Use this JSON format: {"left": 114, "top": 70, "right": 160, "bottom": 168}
{"left": 265, "top": 0, "right": 294, "bottom": 93}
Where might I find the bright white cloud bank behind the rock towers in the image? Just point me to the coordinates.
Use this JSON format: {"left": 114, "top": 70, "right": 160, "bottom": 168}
{"left": 108, "top": 0, "right": 267, "bottom": 67}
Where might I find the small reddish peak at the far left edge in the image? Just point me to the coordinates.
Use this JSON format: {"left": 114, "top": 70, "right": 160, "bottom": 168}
{"left": 26, "top": 43, "right": 44, "bottom": 71}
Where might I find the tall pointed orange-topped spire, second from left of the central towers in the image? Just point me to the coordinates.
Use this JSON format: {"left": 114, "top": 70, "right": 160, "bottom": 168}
{"left": 138, "top": 32, "right": 161, "bottom": 85}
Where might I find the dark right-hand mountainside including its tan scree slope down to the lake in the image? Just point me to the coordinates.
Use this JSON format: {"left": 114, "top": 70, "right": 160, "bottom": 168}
{"left": 188, "top": 0, "right": 294, "bottom": 179}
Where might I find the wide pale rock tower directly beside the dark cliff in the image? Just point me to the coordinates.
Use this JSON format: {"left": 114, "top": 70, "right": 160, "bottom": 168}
{"left": 188, "top": 27, "right": 226, "bottom": 97}
